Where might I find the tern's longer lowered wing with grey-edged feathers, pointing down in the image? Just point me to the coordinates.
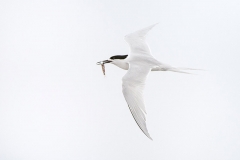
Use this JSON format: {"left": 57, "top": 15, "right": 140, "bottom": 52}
{"left": 122, "top": 63, "right": 152, "bottom": 139}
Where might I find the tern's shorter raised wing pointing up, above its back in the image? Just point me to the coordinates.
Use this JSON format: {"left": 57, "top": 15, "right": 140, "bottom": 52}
{"left": 125, "top": 24, "right": 157, "bottom": 55}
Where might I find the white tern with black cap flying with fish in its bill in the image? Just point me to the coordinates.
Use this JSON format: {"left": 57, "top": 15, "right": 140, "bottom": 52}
{"left": 97, "top": 24, "right": 194, "bottom": 140}
